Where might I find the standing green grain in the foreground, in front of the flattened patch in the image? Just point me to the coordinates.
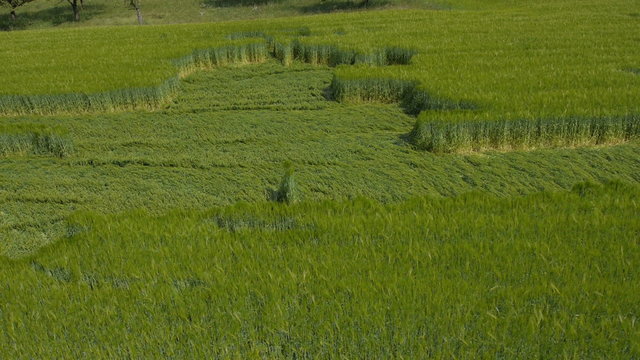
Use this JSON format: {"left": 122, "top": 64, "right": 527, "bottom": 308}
{"left": 0, "top": 183, "right": 640, "bottom": 359}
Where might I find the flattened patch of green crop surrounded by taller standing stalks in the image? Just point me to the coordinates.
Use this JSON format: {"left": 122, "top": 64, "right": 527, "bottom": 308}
{"left": 0, "top": 62, "right": 640, "bottom": 257}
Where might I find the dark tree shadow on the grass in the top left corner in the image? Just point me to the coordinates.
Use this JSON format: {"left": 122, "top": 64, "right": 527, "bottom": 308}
{"left": 0, "top": 4, "right": 104, "bottom": 31}
